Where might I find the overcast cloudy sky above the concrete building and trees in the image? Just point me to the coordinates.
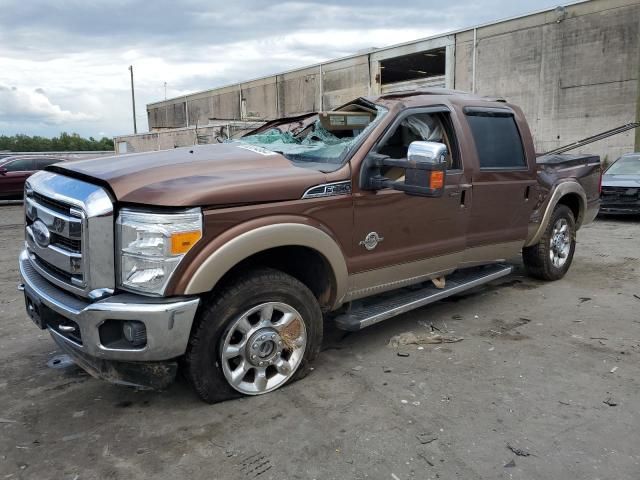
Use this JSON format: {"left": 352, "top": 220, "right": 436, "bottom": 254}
{"left": 0, "top": 0, "right": 559, "bottom": 137}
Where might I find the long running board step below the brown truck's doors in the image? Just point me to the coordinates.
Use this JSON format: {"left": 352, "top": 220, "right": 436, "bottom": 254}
{"left": 335, "top": 264, "right": 513, "bottom": 331}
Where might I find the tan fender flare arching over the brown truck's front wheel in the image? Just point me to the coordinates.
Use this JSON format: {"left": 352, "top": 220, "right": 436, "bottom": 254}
{"left": 184, "top": 223, "right": 349, "bottom": 305}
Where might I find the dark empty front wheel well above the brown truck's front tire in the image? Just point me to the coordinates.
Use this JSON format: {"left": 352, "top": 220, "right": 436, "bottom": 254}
{"left": 218, "top": 245, "right": 336, "bottom": 310}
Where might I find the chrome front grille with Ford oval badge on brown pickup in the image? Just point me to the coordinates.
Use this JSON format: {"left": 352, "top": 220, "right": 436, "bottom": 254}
{"left": 25, "top": 171, "right": 115, "bottom": 297}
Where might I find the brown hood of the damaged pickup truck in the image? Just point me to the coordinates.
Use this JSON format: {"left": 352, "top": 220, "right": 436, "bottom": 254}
{"left": 49, "top": 143, "right": 326, "bottom": 207}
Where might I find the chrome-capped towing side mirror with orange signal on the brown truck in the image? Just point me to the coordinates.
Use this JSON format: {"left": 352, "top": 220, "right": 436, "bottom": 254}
{"left": 363, "top": 141, "right": 448, "bottom": 197}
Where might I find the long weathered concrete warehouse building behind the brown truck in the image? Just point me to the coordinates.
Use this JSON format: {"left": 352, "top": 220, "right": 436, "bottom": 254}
{"left": 122, "top": 0, "right": 640, "bottom": 160}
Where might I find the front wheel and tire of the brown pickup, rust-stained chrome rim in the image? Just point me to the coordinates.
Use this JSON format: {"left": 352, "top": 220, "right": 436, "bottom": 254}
{"left": 184, "top": 269, "right": 322, "bottom": 403}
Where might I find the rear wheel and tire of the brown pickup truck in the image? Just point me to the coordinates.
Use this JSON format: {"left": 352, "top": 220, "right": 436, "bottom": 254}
{"left": 522, "top": 205, "right": 576, "bottom": 280}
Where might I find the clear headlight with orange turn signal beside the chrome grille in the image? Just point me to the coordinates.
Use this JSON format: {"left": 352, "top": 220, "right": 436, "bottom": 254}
{"left": 116, "top": 209, "right": 202, "bottom": 295}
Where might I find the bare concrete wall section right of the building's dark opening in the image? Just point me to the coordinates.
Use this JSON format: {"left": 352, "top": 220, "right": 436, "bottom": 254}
{"left": 455, "top": 0, "right": 640, "bottom": 160}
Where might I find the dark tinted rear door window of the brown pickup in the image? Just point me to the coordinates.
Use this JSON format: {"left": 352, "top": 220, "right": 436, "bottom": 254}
{"left": 467, "top": 112, "right": 527, "bottom": 168}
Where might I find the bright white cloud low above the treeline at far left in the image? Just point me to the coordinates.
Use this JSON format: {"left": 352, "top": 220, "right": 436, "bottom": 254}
{"left": 0, "top": 84, "right": 97, "bottom": 125}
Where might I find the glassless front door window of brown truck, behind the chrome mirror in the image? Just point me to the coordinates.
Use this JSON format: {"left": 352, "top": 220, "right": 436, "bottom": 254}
{"left": 377, "top": 113, "right": 460, "bottom": 174}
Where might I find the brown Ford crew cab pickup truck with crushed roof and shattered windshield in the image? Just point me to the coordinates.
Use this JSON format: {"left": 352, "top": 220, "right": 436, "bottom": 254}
{"left": 20, "top": 89, "right": 600, "bottom": 402}
